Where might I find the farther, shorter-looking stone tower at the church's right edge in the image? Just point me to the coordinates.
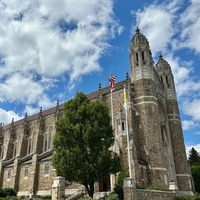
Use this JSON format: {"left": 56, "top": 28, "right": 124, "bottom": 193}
{"left": 156, "top": 55, "right": 193, "bottom": 194}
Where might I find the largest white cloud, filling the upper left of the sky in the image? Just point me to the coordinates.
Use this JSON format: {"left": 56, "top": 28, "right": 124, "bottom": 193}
{"left": 0, "top": 0, "right": 121, "bottom": 93}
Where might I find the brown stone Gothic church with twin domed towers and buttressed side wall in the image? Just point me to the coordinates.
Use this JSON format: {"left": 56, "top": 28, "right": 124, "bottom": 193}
{"left": 0, "top": 28, "right": 194, "bottom": 196}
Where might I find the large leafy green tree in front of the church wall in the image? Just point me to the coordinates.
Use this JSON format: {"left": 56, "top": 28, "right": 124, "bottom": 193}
{"left": 53, "top": 92, "right": 120, "bottom": 197}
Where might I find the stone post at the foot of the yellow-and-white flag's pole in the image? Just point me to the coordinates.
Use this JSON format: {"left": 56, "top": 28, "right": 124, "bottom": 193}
{"left": 123, "top": 178, "right": 135, "bottom": 200}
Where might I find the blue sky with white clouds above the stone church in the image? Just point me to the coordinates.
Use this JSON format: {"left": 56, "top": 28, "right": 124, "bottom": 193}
{"left": 0, "top": 0, "right": 200, "bottom": 155}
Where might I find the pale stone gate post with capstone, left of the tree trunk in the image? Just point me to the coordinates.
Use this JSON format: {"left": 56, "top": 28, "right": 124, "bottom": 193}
{"left": 51, "top": 176, "right": 65, "bottom": 200}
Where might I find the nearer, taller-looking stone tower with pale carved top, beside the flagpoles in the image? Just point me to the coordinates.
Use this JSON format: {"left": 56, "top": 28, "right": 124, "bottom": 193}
{"left": 130, "top": 28, "right": 168, "bottom": 186}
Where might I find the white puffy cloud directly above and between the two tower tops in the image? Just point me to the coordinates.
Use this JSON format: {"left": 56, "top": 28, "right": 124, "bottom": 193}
{"left": 132, "top": 1, "right": 180, "bottom": 56}
